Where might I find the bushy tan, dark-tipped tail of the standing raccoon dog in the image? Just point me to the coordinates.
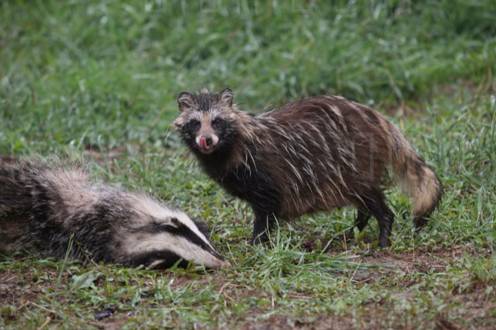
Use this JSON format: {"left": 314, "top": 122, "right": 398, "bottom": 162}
{"left": 390, "top": 124, "right": 443, "bottom": 229}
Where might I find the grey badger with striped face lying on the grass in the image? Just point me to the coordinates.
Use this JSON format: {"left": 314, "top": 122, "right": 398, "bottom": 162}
{"left": 0, "top": 160, "right": 229, "bottom": 268}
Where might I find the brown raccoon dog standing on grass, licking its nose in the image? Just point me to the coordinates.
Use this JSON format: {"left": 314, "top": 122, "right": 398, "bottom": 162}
{"left": 174, "top": 89, "right": 442, "bottom": 246}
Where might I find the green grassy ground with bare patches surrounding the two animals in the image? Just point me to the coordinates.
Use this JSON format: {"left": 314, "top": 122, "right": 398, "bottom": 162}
{"left": 0, "top": 0, "right": 496, "bottom": 329}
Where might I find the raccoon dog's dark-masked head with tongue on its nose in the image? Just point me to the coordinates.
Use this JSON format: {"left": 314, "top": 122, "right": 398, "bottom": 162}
{"left": 174, "top": 88, "right": 236, "bottom": 155}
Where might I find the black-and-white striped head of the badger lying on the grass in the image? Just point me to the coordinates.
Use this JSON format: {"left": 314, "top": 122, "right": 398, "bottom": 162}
{"left": 120, "top": 198, "right": 229, "bottom": 268}
